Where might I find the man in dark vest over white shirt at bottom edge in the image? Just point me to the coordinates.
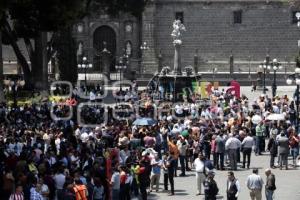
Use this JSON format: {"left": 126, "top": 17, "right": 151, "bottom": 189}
{"left": 227, "top": 171, "right": 241, "bottom": 200}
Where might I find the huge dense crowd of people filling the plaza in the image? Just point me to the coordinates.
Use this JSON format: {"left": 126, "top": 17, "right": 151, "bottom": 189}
{"left": 0, "top": 81, "right": 299, "bottom": 200}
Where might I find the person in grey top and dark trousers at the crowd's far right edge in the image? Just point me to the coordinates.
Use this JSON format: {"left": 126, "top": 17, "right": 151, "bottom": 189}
{"left": 277, "top": 131, "right": 289, "bottom": 170}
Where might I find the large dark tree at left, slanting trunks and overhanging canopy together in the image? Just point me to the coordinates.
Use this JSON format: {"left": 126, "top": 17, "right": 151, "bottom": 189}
{"left": 1, "top": 0, "right": 87, "bottom": 90}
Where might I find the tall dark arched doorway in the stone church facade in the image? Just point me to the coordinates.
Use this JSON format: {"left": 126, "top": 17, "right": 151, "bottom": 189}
{"left": 93, "top": 26, "right": 116, "bottom": 73}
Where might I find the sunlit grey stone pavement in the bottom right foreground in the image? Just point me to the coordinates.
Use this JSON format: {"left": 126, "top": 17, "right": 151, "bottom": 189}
{"left": 149, "top": 153, "right": 300, "bottom": 200}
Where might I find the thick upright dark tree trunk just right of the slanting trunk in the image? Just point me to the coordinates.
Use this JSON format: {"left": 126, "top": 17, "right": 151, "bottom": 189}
{"left": 31, "top": 32, "right": 48, "bottom": 93}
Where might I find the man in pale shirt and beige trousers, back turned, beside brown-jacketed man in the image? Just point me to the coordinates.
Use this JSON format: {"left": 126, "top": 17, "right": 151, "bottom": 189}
{"left": 246, "top": 169, "right": 264, "bottom": 200}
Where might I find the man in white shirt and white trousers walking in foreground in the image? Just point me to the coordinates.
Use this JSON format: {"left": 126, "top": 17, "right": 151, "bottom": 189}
{"left": 194, "top": 153, "right": 208, "bottom": 195}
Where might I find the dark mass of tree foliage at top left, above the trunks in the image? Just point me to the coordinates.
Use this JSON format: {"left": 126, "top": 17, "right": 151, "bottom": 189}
{"left": 9, "top": 0, "right": 87, "bottom": 36}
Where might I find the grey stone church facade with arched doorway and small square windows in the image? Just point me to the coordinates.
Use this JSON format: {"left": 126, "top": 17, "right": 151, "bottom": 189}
{"left": 74, "top": 0, "right": 300, "bottom": 78}
